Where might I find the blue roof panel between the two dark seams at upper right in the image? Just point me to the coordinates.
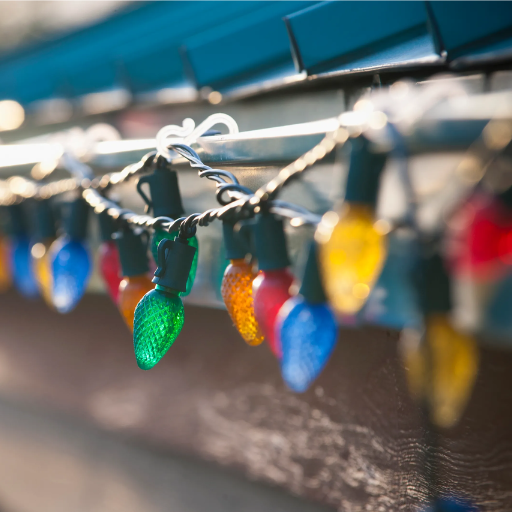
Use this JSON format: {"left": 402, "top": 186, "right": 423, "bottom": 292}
{"left": 286, "top": 1, "right": 439, "bottom": 74}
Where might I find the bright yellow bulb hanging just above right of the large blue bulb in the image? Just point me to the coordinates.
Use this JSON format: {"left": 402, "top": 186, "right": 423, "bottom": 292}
{"left": 315, "top": 203, "right": 389, "bottom": 314}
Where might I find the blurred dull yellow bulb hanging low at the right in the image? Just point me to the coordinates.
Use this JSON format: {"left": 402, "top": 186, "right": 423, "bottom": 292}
{"left": 402, "top": 314, "right": 479, "bottom": 428}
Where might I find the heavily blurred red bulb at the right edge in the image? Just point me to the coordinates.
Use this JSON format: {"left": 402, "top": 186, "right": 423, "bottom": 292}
{"left": 446, "top": 192, "right": 512, "bottom": 282}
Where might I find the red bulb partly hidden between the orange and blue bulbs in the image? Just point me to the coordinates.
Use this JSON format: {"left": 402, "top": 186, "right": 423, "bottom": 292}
{"left": 252, "top": 268, "right": 293, "bottom": 358}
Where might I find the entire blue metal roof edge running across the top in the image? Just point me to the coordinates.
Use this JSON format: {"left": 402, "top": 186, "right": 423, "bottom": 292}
{"left": 0, "top": 1, "right": 512, "bottom": 105}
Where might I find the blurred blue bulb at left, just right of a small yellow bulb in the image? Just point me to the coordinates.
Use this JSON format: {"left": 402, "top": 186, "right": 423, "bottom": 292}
{"left": 50, "top": 235, "right": 91, "bottom": 313}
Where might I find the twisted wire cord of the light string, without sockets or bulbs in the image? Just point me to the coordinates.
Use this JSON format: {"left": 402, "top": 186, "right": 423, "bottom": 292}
{"left": 0, "top": 118, "right": 348, "bottom": 238}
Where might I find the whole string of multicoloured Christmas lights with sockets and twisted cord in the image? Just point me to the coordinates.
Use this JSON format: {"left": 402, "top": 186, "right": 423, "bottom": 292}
{"left": 0, "top": 91, "right": 512, "bottom": 480}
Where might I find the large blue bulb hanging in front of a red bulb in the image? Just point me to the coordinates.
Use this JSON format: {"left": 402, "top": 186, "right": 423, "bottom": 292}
{"left": 276, "top": 296, "right": 338, "bottom": 393}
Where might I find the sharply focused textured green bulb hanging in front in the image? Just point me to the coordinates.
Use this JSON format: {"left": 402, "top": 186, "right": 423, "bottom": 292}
{"left": 133, "top": 285, "right": 185, "bottom": 370}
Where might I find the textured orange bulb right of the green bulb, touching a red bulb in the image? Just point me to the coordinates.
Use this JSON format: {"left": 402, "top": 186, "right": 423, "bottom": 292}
{"left": 221, "top": 259, "right": 264, "bottom": 345}
